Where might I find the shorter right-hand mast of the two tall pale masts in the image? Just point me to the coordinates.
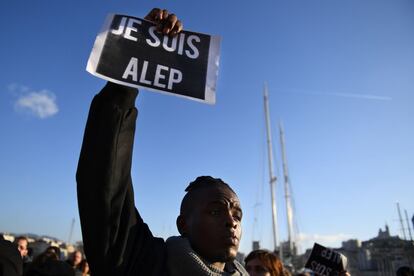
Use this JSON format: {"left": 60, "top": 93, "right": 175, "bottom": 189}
{"left": 279, "top": 121, "right": 294, "bottom": 255}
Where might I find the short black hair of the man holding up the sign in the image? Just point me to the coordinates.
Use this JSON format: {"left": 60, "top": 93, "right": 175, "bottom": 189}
{"left": 180, "top": 176, "right": 236, "bottom": 215}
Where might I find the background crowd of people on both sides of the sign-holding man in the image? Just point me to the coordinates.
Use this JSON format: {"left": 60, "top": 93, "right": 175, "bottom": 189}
{"left": 0, "top": 236, "right": 358, "bottom": 276}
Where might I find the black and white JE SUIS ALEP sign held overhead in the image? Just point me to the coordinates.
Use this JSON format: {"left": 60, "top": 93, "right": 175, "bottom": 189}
{"left": 86, "top": 14, "right": 220, "bottom": 104}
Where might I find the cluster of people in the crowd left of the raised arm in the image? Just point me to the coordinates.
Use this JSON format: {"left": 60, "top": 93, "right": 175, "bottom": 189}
{"left": 0, "top": 235, "right": 90, "bottom": 276}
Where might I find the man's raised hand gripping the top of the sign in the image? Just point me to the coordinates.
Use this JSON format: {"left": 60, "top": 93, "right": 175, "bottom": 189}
{"left": 145, "top": 8, "right": 183, "bottom": 36}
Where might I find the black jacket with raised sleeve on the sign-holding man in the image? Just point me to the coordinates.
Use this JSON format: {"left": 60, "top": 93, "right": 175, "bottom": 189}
{"left": 76, "top": 82, "right": 166, "bottom": 275}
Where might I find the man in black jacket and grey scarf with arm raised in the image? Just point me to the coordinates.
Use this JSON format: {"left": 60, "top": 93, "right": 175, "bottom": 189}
{"left": 76, "top": 9, "right": 248, "bottom": 276}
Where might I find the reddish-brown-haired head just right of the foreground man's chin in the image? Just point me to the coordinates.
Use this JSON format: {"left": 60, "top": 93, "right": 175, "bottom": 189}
{"left": 244, "top": 249, "right": 286, "bottom": 276}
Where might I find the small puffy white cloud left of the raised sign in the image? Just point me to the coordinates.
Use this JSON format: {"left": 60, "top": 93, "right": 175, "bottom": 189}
{"left": 8, "top": 84, "right": 59, "bottom": 119}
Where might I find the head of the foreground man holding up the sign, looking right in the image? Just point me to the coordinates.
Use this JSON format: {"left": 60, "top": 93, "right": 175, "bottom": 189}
{"left": 177, "top": 176, "right": 242, "bottom": 264}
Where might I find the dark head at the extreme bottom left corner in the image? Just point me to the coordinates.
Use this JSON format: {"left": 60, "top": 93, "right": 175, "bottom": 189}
{"left": 0, "top": 238, "right": 23, "bottom": 276}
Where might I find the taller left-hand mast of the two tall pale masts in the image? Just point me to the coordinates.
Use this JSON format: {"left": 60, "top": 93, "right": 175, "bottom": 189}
{"left": 264, "top": 83, "right": 283, "bottom": 259}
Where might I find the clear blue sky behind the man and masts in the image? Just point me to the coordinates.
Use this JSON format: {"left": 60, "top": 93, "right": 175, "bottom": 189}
{"left": 0, "top": 0, "right": 414, "bottom": 253}
